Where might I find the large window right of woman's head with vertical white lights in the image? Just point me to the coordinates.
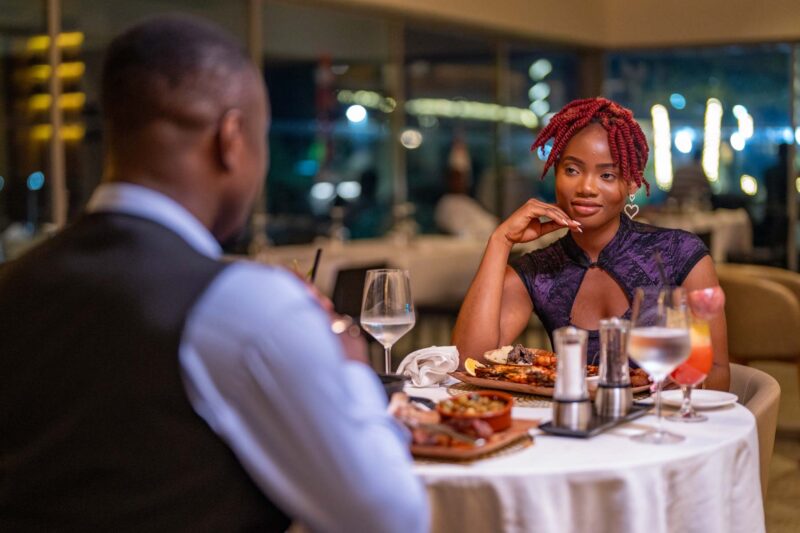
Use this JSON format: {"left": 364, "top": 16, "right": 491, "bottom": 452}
{"left": 605, "top": 44, "right": 794, "bottom": 260}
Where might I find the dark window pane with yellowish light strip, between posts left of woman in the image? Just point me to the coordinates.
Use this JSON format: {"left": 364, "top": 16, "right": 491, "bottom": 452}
{"left": 404, "top": 28, "right": 497, "bottom": 232}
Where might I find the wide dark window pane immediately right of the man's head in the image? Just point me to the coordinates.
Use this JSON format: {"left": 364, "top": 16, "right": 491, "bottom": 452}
{"left": 262, "top": 2, "right": 395, "bottom": 244}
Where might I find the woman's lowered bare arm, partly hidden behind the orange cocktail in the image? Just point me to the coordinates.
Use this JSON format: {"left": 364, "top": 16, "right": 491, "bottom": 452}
{"left": 682, "top": 256, "right": 731, "bottom": 391}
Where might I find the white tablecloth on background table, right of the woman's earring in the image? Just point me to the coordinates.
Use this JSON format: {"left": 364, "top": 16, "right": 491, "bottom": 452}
{"left": 643, "top": 209, "right": 753, "bottom": 263}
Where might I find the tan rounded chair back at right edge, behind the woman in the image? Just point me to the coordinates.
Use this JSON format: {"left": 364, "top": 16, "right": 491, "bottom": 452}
{"left": 717, "top": 265, "right": 800, "bottom": 390}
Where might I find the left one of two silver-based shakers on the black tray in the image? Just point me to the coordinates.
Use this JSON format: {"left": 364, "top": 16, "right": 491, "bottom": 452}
{"left": 553, "top": 326, "right": 592, "bottom": 430}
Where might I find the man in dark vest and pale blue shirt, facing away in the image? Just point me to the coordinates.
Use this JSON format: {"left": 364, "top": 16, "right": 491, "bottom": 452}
{"left": 0, "top": 18, "right": 428, "bottom": 532}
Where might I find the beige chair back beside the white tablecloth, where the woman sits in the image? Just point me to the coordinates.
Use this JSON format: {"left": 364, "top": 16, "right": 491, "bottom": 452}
{"left": 730, "top": 364, "right": 781, "bottom": 500}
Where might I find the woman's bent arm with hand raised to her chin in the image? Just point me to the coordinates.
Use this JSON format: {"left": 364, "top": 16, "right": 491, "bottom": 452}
{"left": 453, "top": 199, "right": 580, "bottom": 364}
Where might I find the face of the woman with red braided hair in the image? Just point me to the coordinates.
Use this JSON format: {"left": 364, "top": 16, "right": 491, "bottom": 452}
{"left": 556, "top": 124, "right": 635, "bottom": 228}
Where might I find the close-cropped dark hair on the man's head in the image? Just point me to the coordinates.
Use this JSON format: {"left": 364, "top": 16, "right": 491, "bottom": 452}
{"left": 101, "top": 16, "right": 254, "bottom": 145}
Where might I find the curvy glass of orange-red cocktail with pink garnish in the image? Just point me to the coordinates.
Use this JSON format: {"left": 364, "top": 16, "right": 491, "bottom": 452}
{"left": 667, "top": 286, "right": 725, "bottom": 422}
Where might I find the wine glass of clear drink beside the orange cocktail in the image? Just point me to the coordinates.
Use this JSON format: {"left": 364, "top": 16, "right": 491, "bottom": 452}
{"left": 628, "top": 287, "right": 691, "bottom": 444}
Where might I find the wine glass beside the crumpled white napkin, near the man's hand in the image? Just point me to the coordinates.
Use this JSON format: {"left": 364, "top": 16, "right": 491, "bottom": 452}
{"left": 361, "top": 269, "right": 416, "bottom": 374}
